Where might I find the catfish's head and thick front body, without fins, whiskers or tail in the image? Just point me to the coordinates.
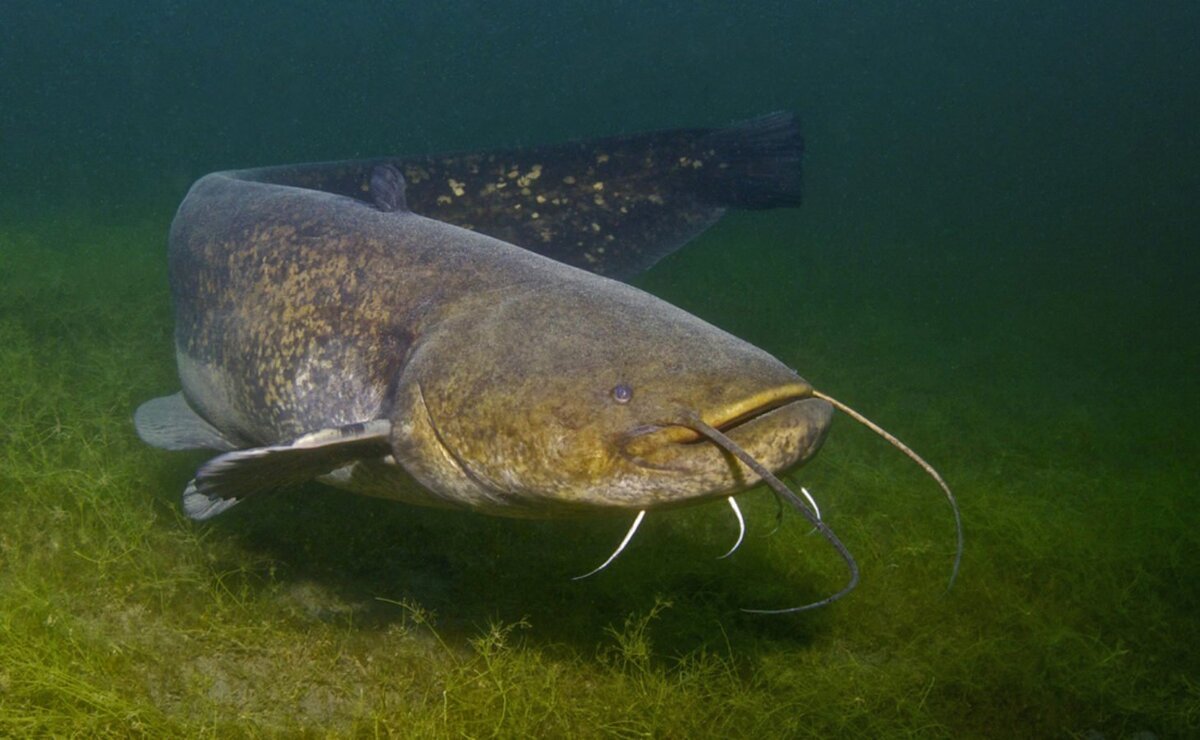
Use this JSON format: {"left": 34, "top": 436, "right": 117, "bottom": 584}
{"left": 170, "top": 166, "right": 830, "bottom": 517}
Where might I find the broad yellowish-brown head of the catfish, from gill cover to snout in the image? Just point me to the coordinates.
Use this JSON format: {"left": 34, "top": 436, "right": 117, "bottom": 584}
{"left": 392, "top": 276, "right": 833, "bottom": 517}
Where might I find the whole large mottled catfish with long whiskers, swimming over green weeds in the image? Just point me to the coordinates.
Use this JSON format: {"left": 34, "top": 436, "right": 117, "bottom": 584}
{"left": 134, "top": 114, "right": 961, "bottom": 612}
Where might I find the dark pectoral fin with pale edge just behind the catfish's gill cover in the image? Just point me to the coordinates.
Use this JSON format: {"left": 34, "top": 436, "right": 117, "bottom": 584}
{"left": 184, "top": 419, "right": 391, "bottom": 521}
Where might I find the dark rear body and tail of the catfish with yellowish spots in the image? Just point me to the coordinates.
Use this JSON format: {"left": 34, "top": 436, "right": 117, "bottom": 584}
{"left": 247, "top": 113, "right": 804, "bottom": 279}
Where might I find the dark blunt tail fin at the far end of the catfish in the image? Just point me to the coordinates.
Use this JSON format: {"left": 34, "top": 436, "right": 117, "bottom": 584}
{"left": 696, "top": 112, "right": 804, "bottom": 210}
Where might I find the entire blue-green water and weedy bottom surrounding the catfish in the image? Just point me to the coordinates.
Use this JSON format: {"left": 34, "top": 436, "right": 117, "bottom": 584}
{"left": 0, "top": 0, "right": 1200, "bottom": 740}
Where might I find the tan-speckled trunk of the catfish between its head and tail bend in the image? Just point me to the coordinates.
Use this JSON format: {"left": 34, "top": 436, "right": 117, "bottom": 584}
{"left": 169, "top": 173, "right": 439, "bottom": 444}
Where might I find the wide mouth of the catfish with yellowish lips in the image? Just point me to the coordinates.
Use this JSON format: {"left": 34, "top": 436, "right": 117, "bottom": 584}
{"left": 622, "top": 381, "right": 832, "bottom": 470}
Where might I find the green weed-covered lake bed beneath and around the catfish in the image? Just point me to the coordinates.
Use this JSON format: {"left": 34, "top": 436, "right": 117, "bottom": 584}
{"left": 0, "top": 204, "right": 1200, "bottom": 738}
